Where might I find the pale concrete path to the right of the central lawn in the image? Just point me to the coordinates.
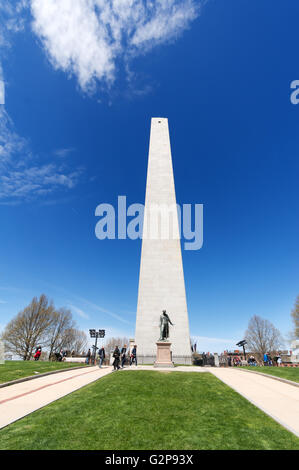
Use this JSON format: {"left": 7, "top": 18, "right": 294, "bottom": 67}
{"left": 209, "top": 367, "right": 299, "bottom": 437}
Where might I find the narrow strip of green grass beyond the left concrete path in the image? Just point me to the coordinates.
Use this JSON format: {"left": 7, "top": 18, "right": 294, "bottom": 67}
{"left": 0, "top": 361, "right": 84, "bottom": 383}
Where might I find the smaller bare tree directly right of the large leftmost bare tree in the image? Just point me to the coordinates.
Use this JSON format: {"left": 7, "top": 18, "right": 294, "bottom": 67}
{"left": 48, "top": 308, "right": 75, "bottom": 359}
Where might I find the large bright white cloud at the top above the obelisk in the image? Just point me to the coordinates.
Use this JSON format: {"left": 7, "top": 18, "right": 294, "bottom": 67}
{"left": 31, "top": 0, "right": 200, "bottom": 91}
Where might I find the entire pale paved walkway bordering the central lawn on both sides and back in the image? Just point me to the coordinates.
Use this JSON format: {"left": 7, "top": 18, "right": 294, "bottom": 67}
{"left": 0, "top": 366, "right": 299, "bottom": 437}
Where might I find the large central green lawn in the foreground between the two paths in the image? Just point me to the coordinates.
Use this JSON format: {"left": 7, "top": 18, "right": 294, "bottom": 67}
{"left": 0, "top": 371, "right": 299, "bottom": 450}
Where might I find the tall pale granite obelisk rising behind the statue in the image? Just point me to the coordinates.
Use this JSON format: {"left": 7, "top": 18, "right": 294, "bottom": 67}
{"left": 135, "top": 118, "right": 191, "bottom": 364}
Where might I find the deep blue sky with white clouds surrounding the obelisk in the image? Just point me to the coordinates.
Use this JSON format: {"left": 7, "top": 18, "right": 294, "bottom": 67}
{"left": 0, "top": 0, "right": 299, "bottom": 352}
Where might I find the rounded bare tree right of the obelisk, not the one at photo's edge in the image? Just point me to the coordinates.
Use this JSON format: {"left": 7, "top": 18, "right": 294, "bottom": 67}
{"left": 245, "top": 315, "right": 283, "bottom": 360}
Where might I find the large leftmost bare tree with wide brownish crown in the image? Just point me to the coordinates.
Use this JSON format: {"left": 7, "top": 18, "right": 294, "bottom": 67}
{"left": 2, "top": 294, "right": 54, "bottom": 361}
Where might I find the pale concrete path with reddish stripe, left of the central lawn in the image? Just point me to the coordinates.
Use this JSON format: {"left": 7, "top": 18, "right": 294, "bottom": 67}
{"left": 0, "top": 366, "right": 112, "bottom": 428}
